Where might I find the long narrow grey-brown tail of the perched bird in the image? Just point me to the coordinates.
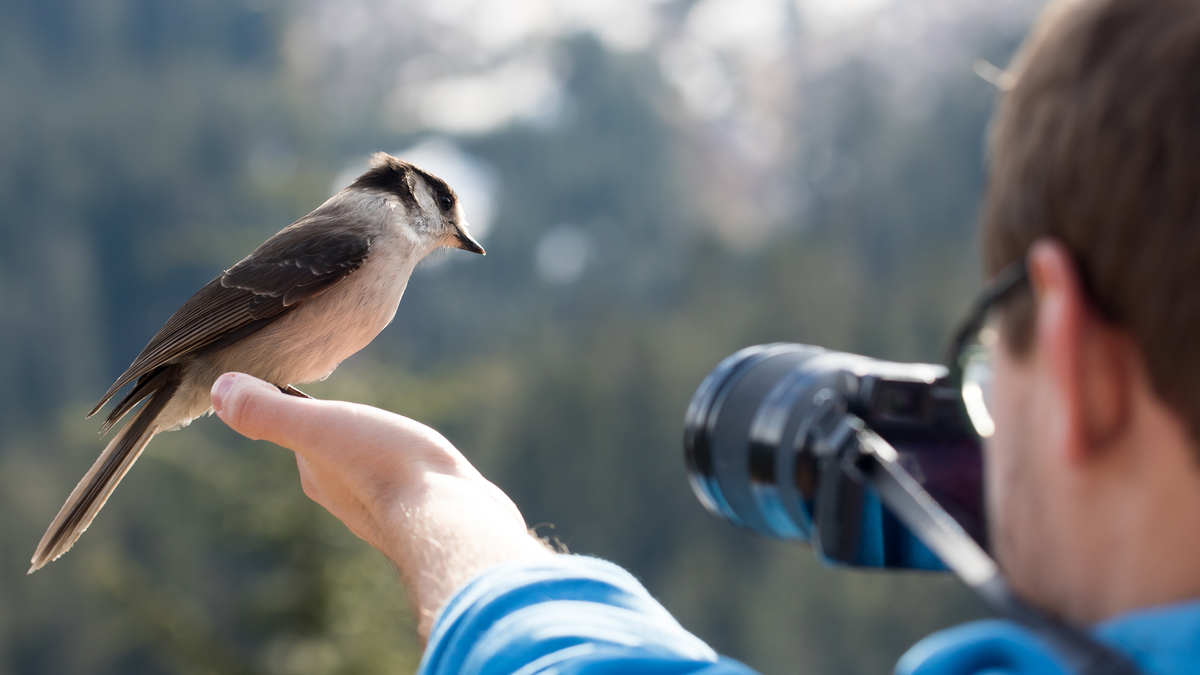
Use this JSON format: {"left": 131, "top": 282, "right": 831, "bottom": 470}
{"left": 29, "top": 365, "right": 182, "bottom": 574}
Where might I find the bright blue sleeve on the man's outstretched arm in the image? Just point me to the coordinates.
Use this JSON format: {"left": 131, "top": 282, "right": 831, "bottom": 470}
{"left": 419, "top": 555, "right": 754, "bottom": 675}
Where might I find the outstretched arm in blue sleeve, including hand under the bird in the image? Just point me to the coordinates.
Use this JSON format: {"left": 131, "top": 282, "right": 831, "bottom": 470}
{"left": 212, "top": 374, "right": 752, "bottom": 675}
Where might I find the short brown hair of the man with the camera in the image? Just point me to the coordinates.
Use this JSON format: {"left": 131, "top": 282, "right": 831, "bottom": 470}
{"left": 982, "top": 0, "right": 1200, "bottom": 440}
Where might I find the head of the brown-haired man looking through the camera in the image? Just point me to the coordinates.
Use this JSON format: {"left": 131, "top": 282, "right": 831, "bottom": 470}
{"left": 983, "top": 0, "right": 1200, "bottom": 621}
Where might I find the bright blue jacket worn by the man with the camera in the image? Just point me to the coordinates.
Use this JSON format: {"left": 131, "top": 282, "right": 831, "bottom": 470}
{"left": 419, "top": 555, "right": 1200, "bottom": 675}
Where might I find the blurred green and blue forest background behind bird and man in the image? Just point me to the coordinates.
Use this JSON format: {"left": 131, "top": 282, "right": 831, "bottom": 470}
{"left": 0, "top": 0, "right": 1038, "bottom": 675}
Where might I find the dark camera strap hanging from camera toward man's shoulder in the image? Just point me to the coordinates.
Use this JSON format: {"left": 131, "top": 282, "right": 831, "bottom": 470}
{"left": 830, "top": 413, "right": 1141, "bottom": 675}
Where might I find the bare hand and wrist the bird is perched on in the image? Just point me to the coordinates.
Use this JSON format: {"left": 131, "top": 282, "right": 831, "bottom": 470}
{"left": 212, "top": 374, "right": 553, "bottom": 640}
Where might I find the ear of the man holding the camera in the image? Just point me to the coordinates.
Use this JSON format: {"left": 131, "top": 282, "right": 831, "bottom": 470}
{"left": 1027, "top": 239, "right": 1133, "bottom": 462}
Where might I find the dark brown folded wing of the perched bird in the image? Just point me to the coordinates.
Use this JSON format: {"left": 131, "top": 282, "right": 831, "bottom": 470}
{"left": 88, "top": 215, "right": 371, "bottom": 415}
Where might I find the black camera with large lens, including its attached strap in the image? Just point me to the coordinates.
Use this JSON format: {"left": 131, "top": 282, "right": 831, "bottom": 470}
{"left": 684, "top": 341, "right": 1139, "bottom": 675}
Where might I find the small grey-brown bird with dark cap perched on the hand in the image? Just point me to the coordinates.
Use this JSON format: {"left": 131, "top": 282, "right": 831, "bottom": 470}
{"left": 29, "top": 153, "right": 485, "bottom": 566}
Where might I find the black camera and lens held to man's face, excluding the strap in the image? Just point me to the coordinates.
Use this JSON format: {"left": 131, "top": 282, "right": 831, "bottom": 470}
{"left": 684, "top": 344, "right": 986, "bottom": 569}
